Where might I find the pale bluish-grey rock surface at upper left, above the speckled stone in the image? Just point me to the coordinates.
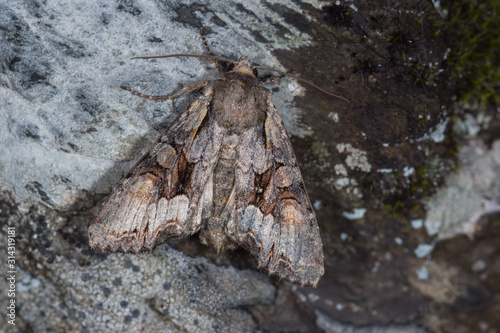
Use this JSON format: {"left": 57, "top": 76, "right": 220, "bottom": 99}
{"left": 0, "top": 1, "right": 307, "bottom": 210}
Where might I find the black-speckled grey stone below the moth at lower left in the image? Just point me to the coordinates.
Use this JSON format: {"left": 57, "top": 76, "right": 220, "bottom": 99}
{"left": 0, "top": 193, "right": 275, "bottom": 332}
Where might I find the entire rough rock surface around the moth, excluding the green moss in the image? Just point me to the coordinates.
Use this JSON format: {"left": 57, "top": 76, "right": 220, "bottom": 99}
{"left": 0, "top": 0, "right": 500, "bottom": 332}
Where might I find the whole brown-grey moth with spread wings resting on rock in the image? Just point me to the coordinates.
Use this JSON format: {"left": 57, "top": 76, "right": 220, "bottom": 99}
{"left": 89, "top": 33, "right": 324, "bottom": 286}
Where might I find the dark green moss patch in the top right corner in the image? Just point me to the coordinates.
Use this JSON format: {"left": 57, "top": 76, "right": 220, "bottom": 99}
{"left": 446, "top": 0, "right": 500, "bottom": 107}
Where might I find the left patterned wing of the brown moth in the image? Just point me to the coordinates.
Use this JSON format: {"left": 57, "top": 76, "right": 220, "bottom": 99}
{"left": 89, "top": 86, "right": 224, "bottom": 253}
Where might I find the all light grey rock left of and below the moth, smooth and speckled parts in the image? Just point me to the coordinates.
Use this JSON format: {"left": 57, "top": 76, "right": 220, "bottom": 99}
{"left": 0, "top": 0, "right": 308, "bottom": 332}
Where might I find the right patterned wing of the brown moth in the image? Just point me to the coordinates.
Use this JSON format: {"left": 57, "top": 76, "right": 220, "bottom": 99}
{"left": 228, "top": 94, "right": 324, "bottom": 286}
